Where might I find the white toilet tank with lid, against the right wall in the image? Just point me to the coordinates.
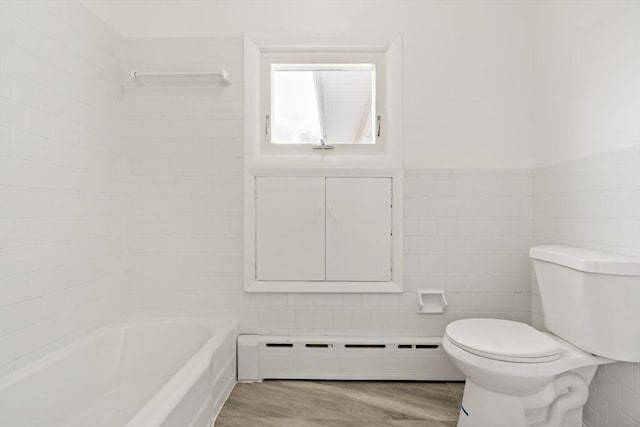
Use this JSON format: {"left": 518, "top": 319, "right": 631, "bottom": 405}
{"left": 529, "top": 245, "right": 640, "bottom": 362}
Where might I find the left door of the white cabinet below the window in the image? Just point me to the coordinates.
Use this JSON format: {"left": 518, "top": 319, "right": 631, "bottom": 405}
{"left": 256, "top": 177, "right": 325, "bottom": 280}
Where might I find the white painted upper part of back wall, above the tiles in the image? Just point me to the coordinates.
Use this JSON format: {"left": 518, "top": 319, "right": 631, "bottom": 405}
{"left": 84, "top": 0, "right": 531, "bottom": 168}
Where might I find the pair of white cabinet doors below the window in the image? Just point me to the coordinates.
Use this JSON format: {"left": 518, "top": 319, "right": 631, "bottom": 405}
{"left": 255, "top": 177, "right": 392, "bottom": 283}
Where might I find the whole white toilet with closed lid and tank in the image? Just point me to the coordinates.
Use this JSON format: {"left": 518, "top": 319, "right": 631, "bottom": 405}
{"left": 443, "top": 246, "right": 640, "bottom": 427}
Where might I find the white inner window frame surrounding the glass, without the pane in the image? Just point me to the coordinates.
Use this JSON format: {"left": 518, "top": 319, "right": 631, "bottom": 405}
{"left": 260, "top": 50, "right": 387, "bottom": 155}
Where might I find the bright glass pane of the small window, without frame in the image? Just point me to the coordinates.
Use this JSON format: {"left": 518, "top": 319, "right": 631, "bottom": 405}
{"left": 272, "top": 64, "right": 375, "bottom": 144}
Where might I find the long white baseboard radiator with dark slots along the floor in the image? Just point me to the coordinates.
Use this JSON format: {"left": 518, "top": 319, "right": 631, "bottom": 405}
{"left": 238, "top": 335, "right": 464, "bottom": 382}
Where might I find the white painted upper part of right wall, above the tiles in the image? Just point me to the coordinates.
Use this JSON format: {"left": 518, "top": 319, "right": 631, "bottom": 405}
{"left": 532, "top": 1, "right": 640, "bottom": 167}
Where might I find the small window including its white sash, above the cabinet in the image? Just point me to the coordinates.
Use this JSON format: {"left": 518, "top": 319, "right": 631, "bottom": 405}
{"left": 262, "top": 52, "right": 384, "bottom": 150}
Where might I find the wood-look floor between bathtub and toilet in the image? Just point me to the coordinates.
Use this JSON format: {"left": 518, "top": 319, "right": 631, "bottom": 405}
{"left": 215, "top": 380, "right": 464, "bottom": 427}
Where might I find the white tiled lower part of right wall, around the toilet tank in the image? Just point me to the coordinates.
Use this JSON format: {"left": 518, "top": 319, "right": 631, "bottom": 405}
{"left": 532, "top": 146, "right": 640, "bottom": 427}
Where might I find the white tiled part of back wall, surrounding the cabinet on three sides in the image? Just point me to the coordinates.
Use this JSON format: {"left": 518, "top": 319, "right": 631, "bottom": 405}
{"left": 125, "top": 38, "right": 531, "bottom": 335}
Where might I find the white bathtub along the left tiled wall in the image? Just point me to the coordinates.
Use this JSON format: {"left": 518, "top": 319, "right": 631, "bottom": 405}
{"left": 0, "top": 319, "right": 236, "bottom": 427}
